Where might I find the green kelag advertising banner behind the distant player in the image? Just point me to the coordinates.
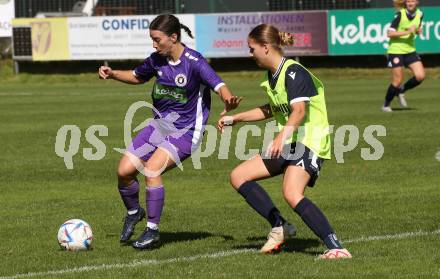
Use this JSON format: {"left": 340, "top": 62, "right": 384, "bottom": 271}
{"left": 328, "top": 8, "right": 440, "bottom": 55}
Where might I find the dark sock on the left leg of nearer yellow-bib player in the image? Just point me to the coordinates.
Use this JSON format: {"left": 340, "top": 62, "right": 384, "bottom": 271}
{"left": 238, "top": 181, "right": 285, "bottom": 228}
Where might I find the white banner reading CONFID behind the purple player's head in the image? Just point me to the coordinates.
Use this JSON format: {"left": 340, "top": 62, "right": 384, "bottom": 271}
{"left": 67, "top": 14, "right": 196, "bottom": 60}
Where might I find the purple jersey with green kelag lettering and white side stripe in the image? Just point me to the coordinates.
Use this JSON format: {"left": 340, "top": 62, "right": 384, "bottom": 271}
{"left": 133, "top": 47, "right": 224, "bottom": 144}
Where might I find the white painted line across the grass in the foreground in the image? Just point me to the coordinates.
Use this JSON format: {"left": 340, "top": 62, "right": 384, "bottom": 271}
{"left": 0, "top": 229, "right": 440, "bottom": 279}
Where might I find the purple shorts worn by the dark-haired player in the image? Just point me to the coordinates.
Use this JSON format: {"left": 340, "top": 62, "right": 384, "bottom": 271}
{"left": 128, "top": 124, "right": 194, "bottom": 162}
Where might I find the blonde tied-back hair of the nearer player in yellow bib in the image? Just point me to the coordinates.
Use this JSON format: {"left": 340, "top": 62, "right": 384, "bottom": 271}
{"left": 248, "top": 24, "right": 295, "bottom": 53}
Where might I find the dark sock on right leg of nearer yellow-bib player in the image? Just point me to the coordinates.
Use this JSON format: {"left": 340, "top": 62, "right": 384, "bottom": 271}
{"left": 295, "top": 198, "right": 342, "bottom": 249}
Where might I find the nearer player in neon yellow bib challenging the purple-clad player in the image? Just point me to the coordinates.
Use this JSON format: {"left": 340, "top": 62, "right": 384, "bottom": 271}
{"left": 218, "top": 24, "right": 351, "bottom": 259}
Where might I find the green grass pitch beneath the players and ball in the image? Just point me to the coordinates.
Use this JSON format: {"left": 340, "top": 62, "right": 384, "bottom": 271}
{"left": 0, "top": 65, "right": 440, "bottom": 278}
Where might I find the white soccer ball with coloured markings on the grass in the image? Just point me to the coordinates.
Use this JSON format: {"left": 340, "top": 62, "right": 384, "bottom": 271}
{"left": 58, "top": 219, "right": 93, "bottom": 251}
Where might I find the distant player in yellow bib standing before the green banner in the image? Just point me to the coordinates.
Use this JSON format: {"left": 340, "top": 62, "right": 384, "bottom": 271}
{"left": 382, "top": 0, "right": 425, "bottom": 112}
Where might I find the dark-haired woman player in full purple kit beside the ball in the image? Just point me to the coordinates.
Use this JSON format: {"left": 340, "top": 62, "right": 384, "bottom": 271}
{"left": 99, "top": 14, "right": 241, "bottom": 249}
